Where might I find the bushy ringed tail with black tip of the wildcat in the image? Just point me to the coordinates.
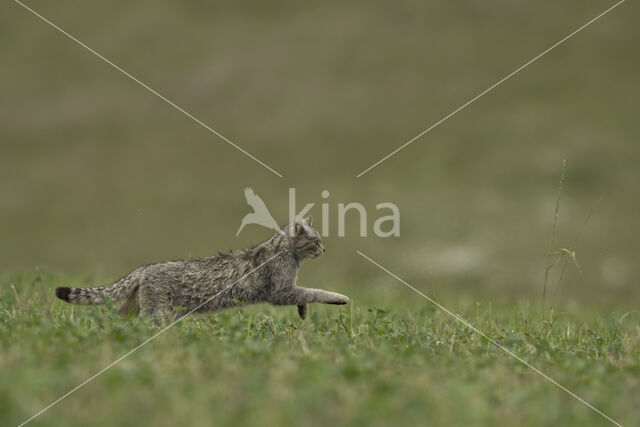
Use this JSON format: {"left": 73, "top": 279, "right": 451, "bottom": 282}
{"left": 56, "top": 273, "right": 140, "bottom": 305}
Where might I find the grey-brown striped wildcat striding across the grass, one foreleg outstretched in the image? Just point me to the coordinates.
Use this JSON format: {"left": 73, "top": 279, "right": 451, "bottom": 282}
{"left": 56, "top": 216, "right": 349, "bottom": 319}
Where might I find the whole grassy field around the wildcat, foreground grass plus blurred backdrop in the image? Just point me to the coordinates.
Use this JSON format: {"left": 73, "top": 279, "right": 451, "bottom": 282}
{"left": 0, "top": 0, "right": 640, "bottom": 426}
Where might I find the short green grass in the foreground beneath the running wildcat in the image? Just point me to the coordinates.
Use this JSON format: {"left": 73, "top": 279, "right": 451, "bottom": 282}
{"left": 0, "top": 273, "right": 640, "bottom": 426}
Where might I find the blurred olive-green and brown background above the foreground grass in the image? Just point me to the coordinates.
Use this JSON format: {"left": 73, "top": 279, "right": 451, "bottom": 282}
{"left": 0, "top": 0, "right": 640, "bottom": 307}
